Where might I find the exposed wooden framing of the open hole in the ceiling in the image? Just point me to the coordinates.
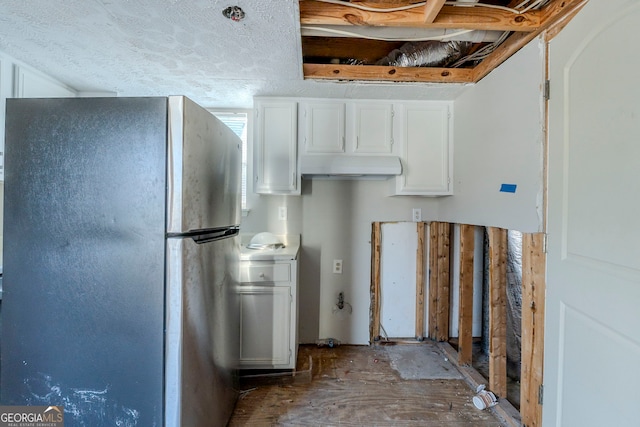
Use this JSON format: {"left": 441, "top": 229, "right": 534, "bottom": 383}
{"left": 299, "top": 0, "right": 588, "bottom": 83}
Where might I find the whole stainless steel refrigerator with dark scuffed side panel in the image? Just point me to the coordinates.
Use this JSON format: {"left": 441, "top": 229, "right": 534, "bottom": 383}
{"left": 0, "top": 96, "right": 241, "bottom": 427}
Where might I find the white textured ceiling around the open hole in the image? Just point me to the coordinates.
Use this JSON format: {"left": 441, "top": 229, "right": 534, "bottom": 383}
{"left": 0, "top": 0, "right": 462, "bottom": 108}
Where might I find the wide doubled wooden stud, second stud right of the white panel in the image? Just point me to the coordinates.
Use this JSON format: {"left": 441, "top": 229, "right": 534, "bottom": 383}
{"left": 429, "top": 222, "right": 451, "bottom": 341}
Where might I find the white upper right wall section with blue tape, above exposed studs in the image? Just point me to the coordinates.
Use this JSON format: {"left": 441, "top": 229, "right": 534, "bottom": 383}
{"left": 438, "top": 39, "right": 544, "bottom": 232}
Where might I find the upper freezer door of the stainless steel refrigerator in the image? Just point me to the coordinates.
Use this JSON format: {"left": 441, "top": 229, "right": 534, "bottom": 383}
{"left": 167, "top": 96, "right": 242, "bottom": 233}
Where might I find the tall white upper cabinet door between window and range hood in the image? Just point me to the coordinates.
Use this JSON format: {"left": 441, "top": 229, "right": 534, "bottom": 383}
{"left": 254, "top": 100, "right": 300, "bottom": 194}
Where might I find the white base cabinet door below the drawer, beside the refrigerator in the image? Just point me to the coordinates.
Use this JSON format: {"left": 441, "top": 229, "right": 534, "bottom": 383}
{"left": 240, "top": 286, "right": 293, "bottom": 368}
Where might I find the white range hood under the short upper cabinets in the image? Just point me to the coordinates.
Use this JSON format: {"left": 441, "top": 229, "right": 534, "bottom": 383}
{"left": 300, "top": 154, "right": 402, "bottom": 179}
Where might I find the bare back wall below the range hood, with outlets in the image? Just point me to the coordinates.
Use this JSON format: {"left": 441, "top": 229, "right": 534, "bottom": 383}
{"left": 242, "top": 179, "right": 437, "bottom": 344}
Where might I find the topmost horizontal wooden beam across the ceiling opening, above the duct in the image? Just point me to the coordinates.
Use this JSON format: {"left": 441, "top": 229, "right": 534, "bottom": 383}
{"left": 299, "top": 0, "right": 542, "bottom": 32}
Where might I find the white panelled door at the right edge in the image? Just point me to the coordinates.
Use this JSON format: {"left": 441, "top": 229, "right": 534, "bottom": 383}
{"left": 543, "top": 0, "right": 640, "bottom": 427}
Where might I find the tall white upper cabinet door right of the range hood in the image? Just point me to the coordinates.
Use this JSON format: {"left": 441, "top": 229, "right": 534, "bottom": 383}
{"left": 395, "top": 103, "right": 453, "bottom": 196}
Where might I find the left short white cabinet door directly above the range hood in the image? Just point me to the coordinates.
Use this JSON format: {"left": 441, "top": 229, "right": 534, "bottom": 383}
{"left": 300, "top": 101, "right": 345, "bottom": 154}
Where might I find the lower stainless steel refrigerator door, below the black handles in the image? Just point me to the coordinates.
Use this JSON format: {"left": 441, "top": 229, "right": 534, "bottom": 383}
{"left": 165, "top": 237, "right": 240, "bottom": 426}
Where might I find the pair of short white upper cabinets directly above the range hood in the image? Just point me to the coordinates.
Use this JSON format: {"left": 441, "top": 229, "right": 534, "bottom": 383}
{"left": 300, "top": 99, "right": 393, "bottom": 155}
